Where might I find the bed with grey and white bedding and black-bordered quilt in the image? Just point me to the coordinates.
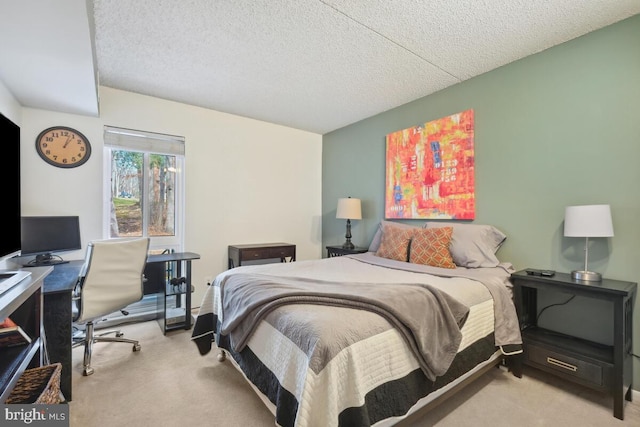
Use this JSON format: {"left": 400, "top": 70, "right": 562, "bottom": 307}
{"left": 192, "top": 221, "right": 522, "bottom": 427}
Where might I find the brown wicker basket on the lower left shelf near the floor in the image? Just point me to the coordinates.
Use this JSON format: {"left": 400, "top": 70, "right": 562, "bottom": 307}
{"left": 6, "top": 363, "right": 62, "bottom": 405}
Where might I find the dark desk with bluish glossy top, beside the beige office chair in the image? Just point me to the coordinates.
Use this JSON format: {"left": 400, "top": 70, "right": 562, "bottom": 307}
{"left": 42, "top": 260, "right": 84, "bottom": 401}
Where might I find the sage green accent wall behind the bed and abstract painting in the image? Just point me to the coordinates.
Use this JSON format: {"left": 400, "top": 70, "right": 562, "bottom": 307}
{"left": 322, "top": 15, "right": 640, "bottom": 389}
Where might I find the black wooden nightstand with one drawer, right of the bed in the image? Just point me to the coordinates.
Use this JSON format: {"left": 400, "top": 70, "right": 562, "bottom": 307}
{"left": 511, "top": 270, "right": 638, "bottom": 420}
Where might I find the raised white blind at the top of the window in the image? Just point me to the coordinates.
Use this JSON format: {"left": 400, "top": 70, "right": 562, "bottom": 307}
{"left": 104, "top": 126, "right": 184, "bottom": 156}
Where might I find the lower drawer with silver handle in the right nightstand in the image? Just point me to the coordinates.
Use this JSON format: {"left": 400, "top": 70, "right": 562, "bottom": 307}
{"left": 524, "top": 344, "right": 606, "bottom": 387}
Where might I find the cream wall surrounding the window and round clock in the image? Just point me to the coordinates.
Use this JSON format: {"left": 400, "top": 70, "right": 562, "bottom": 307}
{"left": 7, "top": 87, "right": 322, "bottom": 306}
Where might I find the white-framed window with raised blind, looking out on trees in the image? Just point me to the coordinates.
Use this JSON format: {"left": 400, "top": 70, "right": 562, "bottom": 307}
{"left": 104, "top": 126, "right": 184, "bottom": 252}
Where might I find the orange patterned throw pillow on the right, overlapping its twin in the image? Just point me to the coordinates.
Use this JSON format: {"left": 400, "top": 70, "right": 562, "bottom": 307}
{"left": 409, "top": 227, "right": 456, "bottom": 268}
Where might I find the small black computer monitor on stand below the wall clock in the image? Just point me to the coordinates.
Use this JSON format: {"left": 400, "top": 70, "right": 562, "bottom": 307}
{"left": 21, "top": 216, "right": 82, "bottom": 266}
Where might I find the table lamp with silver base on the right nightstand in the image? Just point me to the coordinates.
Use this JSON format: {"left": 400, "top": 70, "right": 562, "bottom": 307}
{"left": 564, "top": 205, "right": 613, "bottom": 282}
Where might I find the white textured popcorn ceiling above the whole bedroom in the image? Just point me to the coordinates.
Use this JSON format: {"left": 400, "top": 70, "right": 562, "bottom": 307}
{"left": 0, "top": 0, "right": 640, "bottom": 134}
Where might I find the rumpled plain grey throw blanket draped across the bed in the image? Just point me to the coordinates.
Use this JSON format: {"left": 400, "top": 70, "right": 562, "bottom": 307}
{"left": 220, "top": 273, "right": 469, "bottom": 380}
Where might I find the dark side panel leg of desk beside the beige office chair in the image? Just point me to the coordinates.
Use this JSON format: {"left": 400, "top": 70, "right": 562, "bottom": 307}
{"left": 43, "top": 291, "right": 72, "bottom": 401}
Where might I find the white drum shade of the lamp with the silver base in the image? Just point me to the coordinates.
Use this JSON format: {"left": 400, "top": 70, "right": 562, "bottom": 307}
{"left": 564, "top": 205, "right": 613, "bottom": 237}
